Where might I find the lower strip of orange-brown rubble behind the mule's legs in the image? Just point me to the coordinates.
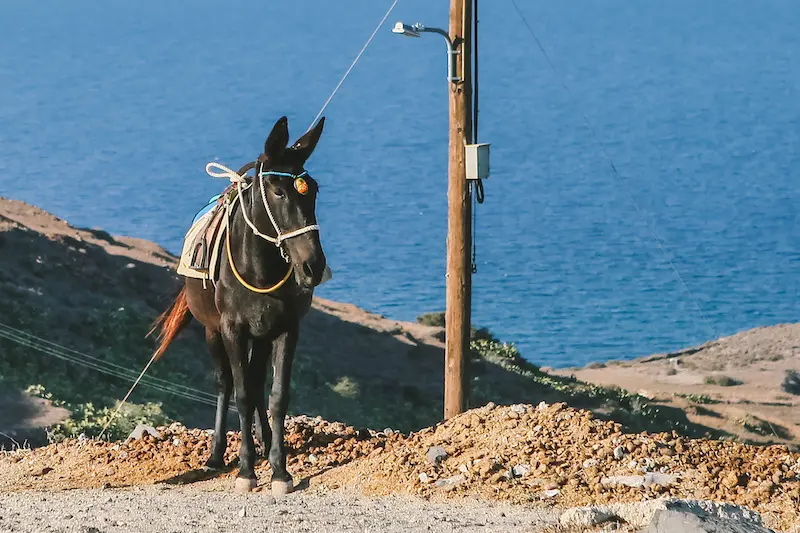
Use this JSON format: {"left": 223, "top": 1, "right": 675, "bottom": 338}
{"left": 0, "top": 416, "right": 401, "bottom": 492}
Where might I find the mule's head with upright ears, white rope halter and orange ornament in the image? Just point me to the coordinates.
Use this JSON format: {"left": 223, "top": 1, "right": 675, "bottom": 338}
{"left": 254, "top": 117, "right": 326, "bottom": 288}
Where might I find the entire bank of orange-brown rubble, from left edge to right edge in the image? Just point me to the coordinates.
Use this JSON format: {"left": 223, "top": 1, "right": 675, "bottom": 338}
{"left": 6, "top": 404, "right": 800, "bottom": 529}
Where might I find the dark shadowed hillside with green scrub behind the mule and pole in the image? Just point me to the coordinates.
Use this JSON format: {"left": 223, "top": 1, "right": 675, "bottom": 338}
{"left": 0, "top": 194, "right": 797, "bottom": 444}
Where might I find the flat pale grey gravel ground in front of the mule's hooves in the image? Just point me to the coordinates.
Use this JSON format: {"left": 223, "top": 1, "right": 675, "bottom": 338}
{"left": 0, "top": 485, "right": 559, "bottom": 533}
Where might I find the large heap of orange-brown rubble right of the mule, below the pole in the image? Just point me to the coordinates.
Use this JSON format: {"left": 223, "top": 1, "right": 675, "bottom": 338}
{"left": 322, "top": 403, "right": 800, "bottom": 529}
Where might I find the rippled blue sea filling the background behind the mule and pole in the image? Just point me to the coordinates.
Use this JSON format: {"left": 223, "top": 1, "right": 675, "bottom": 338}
{"left": 0, "top": 0, "right": 800, "bottom": 366}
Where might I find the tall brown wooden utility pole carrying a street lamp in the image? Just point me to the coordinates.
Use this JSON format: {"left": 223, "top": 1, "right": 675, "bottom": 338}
{"left": 444, "top": 0, "right": 473, "bottom": 419}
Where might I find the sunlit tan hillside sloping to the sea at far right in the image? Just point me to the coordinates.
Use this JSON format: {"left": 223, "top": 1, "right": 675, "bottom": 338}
{"left": 555, "top": 324, "right": 800, "bottom": 447}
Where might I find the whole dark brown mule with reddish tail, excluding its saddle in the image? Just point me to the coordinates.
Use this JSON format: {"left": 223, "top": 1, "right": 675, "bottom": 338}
{"left": 150, "top": 117, "right": 325, "bottom": 494}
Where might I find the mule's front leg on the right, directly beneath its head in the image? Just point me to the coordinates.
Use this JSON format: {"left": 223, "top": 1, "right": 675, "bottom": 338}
{"left": 269, "top": 324, "right": 298, "bottom": 495}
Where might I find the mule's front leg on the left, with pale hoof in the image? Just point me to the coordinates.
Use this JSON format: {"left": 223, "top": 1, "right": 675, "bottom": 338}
{"left": 222, "top": 320, "right": 258, "bottom": 492}
